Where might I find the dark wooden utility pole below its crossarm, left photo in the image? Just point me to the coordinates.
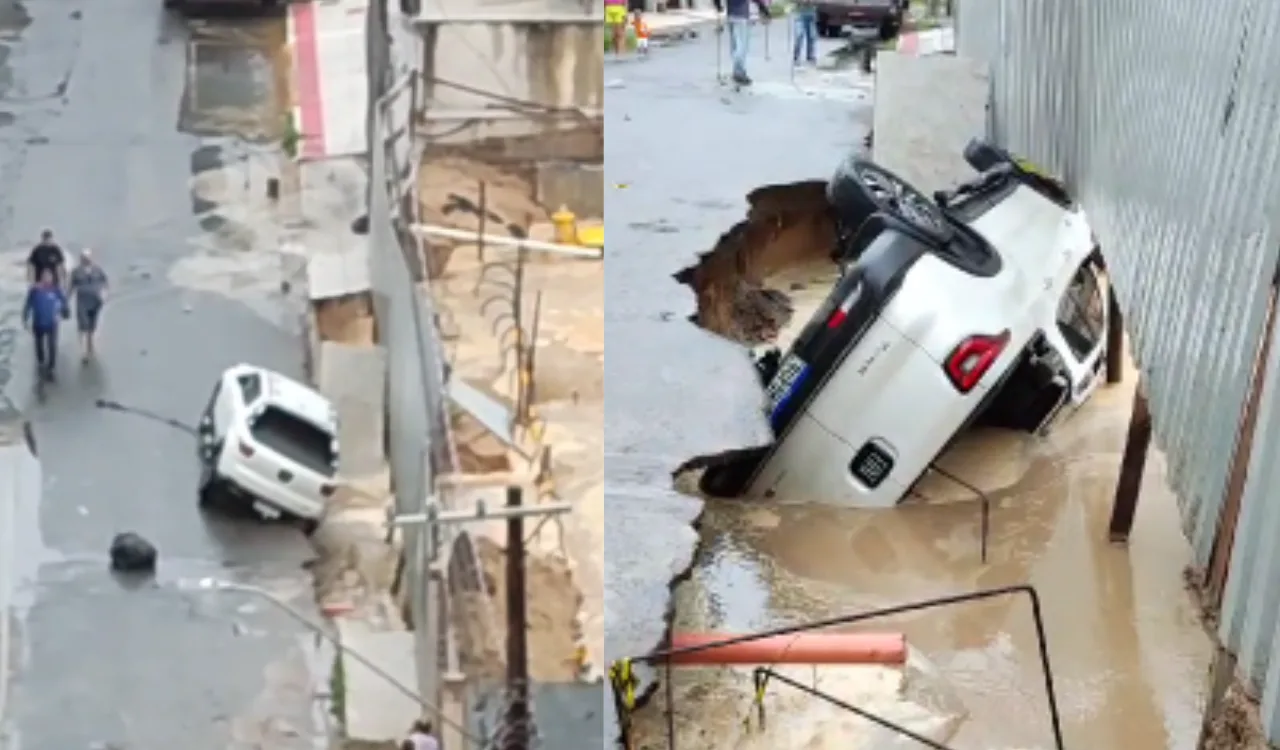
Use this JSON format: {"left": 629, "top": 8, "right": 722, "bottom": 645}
{"left": 502, "top": 485, "right": 532, "bottom": 750}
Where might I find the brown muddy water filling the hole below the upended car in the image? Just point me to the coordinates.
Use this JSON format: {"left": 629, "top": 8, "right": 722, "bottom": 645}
{"left": 634, "top": 371, "right": 1210, "bottom": 749}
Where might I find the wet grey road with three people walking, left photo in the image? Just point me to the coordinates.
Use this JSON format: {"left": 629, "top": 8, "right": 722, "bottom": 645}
{"left": 0, "top": 0, "right": 320, "bottom": 750}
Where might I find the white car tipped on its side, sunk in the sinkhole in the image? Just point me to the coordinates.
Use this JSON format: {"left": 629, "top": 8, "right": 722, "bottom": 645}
{"left": 701, "top": 142, "right": 1107, "bottom": 507}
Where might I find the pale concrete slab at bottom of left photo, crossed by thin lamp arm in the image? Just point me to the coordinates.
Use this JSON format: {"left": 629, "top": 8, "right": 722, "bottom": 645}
{"left": 337, "top": 618, "right": 421, "bottom": 742}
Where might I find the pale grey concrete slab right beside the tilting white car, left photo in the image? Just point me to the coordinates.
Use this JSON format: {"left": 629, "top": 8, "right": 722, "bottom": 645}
{"left": 316, "top": 342, "right": 387, "bottom": 476}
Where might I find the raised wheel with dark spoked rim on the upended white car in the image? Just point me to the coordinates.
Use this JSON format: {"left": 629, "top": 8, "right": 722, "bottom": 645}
{"left": 827, "top": 154, "right": 955, "bottom": 243}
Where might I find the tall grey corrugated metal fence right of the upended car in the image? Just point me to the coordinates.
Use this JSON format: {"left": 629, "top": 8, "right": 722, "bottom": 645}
{"left": 956, "top": 0, "right": 1280, "bottom": 744}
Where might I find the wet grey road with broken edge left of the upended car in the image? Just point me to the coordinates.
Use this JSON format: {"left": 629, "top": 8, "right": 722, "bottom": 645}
{"left": 604, "top": 23, "right": 870, "bottom": 696}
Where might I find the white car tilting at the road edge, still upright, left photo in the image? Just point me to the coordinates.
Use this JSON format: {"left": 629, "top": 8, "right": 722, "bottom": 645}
{"left": 197, "top": 365, "right": 338, "bottom": 532}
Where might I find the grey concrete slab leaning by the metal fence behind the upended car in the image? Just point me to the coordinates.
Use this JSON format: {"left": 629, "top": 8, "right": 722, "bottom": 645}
{"left": 873, "top": 51, "right": 991, "bottom": 195}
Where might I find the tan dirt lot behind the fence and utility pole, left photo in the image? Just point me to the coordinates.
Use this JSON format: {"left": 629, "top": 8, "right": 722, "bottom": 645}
{"left": 419, "top": 156, "right": 603, "bottom": 682}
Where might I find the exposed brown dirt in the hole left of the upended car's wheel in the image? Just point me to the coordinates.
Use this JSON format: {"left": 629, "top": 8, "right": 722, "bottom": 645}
{"left": 675, "top": 180, "right": 836, "bottom": 346}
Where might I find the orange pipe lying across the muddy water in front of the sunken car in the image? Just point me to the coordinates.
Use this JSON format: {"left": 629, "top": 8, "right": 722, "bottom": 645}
{"left": 655, "top": 632, "right": 906, "bottom": 667}
